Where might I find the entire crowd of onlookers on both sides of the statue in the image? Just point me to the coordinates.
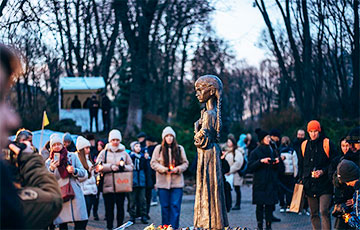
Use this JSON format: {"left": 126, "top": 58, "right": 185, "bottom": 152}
{"left": 0, "top": 45, "right": 360, "bottom": 229}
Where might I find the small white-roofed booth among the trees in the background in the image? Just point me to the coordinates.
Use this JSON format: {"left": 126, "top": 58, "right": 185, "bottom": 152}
{"left": 59, "top": 77, "right": 105, "bottom": 132}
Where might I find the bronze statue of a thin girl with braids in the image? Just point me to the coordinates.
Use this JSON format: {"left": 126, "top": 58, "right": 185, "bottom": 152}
{"left": 194, "top": 75, "right": 229, "bottom": 229}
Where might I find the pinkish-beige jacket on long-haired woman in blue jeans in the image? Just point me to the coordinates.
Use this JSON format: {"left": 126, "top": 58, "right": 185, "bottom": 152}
{"left": 150, "top": 145, "right": 189, "bottom": 189}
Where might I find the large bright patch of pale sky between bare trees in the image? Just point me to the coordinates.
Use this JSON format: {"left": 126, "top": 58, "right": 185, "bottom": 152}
{"left": 212, "top": 0, "right": 279, "bottom": 66}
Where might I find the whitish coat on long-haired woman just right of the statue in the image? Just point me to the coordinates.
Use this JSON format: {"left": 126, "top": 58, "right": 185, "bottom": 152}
{"left": 225, "top": 148, "right": 244, "bottom": 186}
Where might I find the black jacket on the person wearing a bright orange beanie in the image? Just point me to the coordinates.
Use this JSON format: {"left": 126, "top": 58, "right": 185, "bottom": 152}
{"left": 299, "top": 137, "right": 338, "bottom": 197}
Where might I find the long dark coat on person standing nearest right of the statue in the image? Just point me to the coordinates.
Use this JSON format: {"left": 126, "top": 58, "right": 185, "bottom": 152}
{"left": 248, "top": 145, "right": 279, "bottom": 205}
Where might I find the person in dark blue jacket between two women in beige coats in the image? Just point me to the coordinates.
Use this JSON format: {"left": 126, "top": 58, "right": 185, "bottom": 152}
{"left": 129, "top": 141, "right": 148, "bottom": 224}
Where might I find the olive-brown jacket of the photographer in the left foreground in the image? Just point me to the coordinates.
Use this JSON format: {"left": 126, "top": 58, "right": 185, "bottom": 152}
{"left": 18, "top": 148, "right": 63, "bottom": 229}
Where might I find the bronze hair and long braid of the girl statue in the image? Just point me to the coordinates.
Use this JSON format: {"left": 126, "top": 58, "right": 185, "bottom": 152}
{"left": 195, "top": 75, "right": 223, "bottom": 141}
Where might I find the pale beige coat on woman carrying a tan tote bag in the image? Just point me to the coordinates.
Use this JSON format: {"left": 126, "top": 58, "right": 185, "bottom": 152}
{"left": 96, "top": 144, "right": 134, "bottom": 194}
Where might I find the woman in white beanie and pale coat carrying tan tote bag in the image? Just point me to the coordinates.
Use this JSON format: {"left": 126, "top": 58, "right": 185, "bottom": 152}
{"left": 96, "top": 129, "right": 134, "bottom": 229}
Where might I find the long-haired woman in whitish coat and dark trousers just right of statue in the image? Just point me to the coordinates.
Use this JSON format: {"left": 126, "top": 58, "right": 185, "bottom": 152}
{"left": 225, "top": 136, "right": 244, "bottom": 210}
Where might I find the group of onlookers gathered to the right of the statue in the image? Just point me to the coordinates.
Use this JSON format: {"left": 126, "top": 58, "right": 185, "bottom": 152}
{"left": 221, "top": 120, "right": 360, "bottom": 229}
